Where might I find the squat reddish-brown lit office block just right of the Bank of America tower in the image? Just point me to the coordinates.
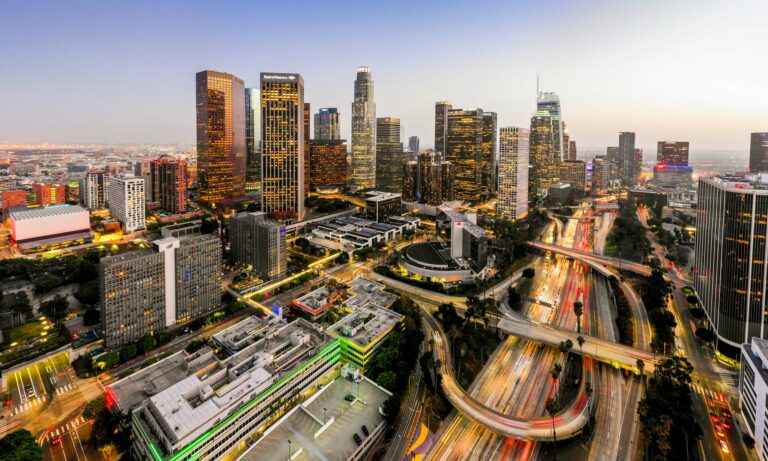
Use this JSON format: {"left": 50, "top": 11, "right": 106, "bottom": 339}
{"left": 309, "top": 139, "right": 348, "bottom": 190}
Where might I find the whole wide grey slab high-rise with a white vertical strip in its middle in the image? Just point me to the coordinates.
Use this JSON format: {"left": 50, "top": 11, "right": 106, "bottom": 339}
{"left": 99, "top": 223, "right": 222, "bottom": 349}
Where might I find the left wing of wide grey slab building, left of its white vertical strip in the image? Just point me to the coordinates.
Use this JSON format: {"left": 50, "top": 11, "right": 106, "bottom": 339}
{"left": 99, "top": 249, "right": 166, "bottom": 349}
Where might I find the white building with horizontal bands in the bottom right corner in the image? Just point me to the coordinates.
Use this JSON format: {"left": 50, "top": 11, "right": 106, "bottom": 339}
{"left": 739, "top": 338, "right": 768, "bottom": 461}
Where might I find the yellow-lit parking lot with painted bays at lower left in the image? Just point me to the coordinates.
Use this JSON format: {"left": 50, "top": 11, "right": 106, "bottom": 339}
{"left": 6, "top": 353, "right": 77, "bottom": 415}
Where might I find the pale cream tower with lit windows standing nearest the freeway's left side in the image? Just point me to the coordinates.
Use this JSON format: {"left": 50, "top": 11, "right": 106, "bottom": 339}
{"left": 496, "top": 127, "right": 530, "bottom": 220}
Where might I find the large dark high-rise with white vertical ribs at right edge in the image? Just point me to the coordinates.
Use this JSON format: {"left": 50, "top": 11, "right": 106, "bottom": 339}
{"left": 693, "top": 174, "right": 768, "bottom": 351}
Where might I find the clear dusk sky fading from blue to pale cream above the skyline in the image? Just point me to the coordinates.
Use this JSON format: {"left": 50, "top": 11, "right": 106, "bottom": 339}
{"left": 0, "top": 0, "right": 768, "bottom": 152}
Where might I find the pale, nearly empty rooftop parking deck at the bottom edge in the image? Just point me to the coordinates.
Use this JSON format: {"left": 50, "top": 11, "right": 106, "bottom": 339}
{"left": 241, "top": 378, "right": 388, "bottom": 461}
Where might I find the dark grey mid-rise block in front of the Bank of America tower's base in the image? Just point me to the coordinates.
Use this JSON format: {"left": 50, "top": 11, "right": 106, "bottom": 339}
{"left": 229, "top": 212, "right": 288, "bottom": 280}
